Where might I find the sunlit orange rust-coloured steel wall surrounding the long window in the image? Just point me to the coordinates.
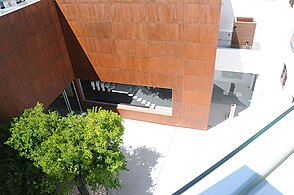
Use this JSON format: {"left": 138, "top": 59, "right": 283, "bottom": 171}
{"left": 56, "top": 0, "right": 221, "bottom": 129}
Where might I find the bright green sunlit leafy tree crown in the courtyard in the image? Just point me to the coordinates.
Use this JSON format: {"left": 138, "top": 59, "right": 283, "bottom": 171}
{"left": 6, "top": 103, "right": 126, "bottom": 193}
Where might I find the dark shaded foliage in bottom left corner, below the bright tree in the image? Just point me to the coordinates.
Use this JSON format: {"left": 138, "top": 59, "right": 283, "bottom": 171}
{"left": 0, "top": 122, "right": 58, "bottom": 195}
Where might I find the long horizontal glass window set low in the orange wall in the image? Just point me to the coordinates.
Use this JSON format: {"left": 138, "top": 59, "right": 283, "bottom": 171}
{"left": 80, "top": 80, "right": 172, "bottom": 112}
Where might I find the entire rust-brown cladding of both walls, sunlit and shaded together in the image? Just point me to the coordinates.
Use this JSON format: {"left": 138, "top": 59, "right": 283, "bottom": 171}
{"left": 0, "top": 0, "right": 221, "bottom": 129}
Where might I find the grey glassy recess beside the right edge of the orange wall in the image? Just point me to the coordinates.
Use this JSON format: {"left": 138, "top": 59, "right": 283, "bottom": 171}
{"left": 208, "top": 70, "right": 258, "bottom": 128}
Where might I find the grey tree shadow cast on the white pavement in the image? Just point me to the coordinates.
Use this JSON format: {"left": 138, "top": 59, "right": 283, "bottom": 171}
{"left": 109, "top": 146, "right": 162, "bottom": 195}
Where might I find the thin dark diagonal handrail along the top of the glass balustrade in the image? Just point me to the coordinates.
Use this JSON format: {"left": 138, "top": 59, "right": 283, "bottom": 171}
{"left": 173, "top": 105, "right": 294, "bottom": 195}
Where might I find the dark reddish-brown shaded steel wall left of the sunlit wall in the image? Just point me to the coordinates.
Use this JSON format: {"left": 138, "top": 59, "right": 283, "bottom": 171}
{"left": 0, "top": 0, "right": 74, "bottom": 122}
